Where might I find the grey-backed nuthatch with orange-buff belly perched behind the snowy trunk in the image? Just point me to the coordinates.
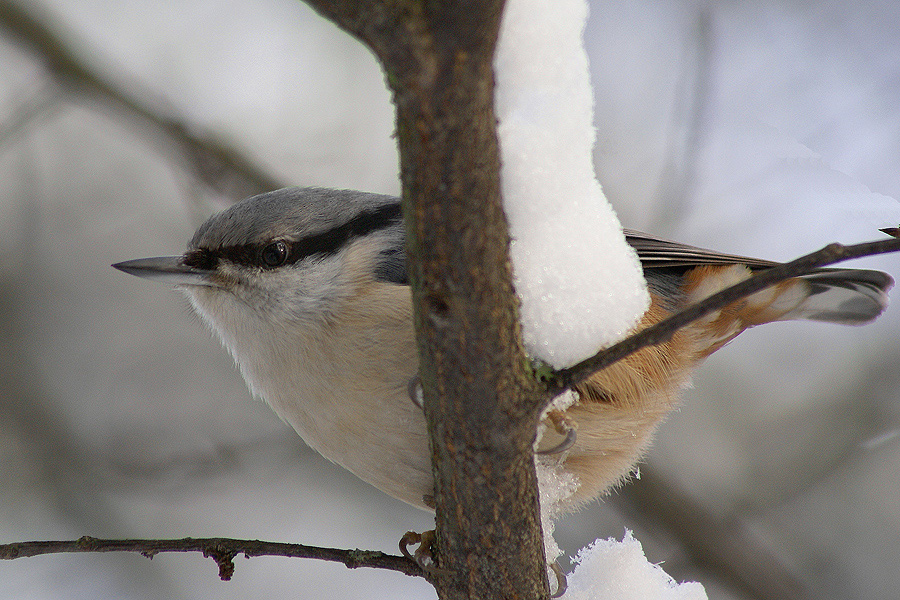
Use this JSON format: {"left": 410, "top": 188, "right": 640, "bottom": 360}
{"left": 112, "top": 187, "right": 893, "bottom": 510}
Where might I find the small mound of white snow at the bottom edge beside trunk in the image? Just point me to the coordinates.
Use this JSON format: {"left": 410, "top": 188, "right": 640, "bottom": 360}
{"left": 563, "top": 530, "right": 707, "bottom": 600}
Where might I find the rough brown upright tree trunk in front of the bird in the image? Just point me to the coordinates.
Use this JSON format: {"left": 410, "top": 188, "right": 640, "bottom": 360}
{"left": 309, "top": 0, "right": 548, "bottom": 600}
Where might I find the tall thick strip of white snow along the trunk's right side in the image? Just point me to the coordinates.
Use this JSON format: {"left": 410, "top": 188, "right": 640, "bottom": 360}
{"left": 495, "top": 0, "right": 649, "bottom": 368}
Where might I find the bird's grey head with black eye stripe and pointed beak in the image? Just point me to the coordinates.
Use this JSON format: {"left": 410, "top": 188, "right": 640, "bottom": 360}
{"left": 113, "top": 188, "right": 406, "bottom": 319}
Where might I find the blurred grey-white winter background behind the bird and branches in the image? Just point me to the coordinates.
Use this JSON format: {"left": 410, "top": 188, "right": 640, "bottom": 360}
{"left": 0, "top": 0, "right": 900, "bottom": 600}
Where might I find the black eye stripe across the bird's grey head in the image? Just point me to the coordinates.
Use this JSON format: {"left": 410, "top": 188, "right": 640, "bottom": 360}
{"left": 184, "top": 204, "right": 400, "bottom": 270}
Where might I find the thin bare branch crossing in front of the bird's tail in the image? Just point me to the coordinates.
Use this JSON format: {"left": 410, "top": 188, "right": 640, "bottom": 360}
{"left": 547, "top": 236, "right": 900, "bottom": 396}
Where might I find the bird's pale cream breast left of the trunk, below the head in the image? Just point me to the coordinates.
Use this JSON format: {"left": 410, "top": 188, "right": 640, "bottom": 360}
{"left": 185, "top": 278, "right": 433, "bottom": 508}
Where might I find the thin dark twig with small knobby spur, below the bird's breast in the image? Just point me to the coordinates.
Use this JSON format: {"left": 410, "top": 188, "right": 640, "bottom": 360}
{"left": 0, "top": 536, "right": 424, "bottom": 581}
